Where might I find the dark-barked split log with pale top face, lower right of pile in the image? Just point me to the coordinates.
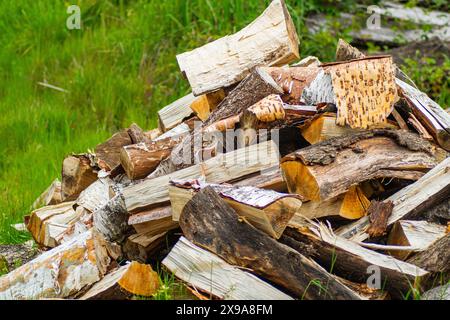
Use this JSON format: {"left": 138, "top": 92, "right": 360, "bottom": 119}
{"left": 286, "top": 224, "right": 429, "bottom": 297}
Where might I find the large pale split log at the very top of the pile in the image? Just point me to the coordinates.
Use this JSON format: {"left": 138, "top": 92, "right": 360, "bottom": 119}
{"left": 177, "top": 0, "right": 300, "bottom": 96}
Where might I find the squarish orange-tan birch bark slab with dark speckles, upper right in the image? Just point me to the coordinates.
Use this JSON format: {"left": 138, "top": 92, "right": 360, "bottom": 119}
{"left": 324, "top": 56, "right": 397, "bottom": 129}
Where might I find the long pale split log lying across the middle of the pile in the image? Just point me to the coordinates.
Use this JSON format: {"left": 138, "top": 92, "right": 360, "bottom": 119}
{"left": 123, "top": 141, "right": 278, "bottom": 213}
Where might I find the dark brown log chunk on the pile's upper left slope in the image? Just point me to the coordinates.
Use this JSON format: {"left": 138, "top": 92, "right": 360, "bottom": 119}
{"left": 95, "top": 129, "right": 133, "bottom": 171}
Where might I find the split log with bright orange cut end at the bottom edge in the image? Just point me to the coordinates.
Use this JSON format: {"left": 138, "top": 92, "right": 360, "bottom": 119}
{"left": 80, "top": 261, "right": 160, "bottom": 300}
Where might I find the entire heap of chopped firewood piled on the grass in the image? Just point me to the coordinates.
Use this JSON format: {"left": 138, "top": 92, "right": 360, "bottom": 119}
{"left": 0, "top": 0, "right": 450, "bottom": 299}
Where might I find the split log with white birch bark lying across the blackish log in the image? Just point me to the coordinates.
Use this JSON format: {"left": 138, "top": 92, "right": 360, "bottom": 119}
{"left": 169, "top": 181, "right": 302, "bottom": 239}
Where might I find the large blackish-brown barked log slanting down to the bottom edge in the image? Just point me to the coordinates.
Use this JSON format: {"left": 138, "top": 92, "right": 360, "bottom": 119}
{"left": 180, "top": 187, "right": 360, "bottom": 299}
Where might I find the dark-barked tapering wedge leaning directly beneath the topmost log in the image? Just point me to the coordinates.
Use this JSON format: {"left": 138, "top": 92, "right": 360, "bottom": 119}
{"left": 204, "top": 68, "right": 283, "bottom": 126}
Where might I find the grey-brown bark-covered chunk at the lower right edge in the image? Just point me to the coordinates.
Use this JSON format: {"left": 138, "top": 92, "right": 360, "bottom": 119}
{"left": 407, "top": 233, "right": 450, "bottom": 282}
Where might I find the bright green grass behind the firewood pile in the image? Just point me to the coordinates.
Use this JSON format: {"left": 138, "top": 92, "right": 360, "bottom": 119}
{"left": 0, "top": 0, "right": 448, "bottom": 243}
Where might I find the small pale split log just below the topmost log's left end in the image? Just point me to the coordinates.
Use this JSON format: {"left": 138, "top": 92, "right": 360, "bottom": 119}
{"left": 158, "top": 93, "right": 195, "bottom": 132}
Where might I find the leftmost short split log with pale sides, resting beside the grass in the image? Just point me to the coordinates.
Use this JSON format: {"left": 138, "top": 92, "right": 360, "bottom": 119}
{"left": 27, "top": 202, "right": 79, "bottom": 247}
